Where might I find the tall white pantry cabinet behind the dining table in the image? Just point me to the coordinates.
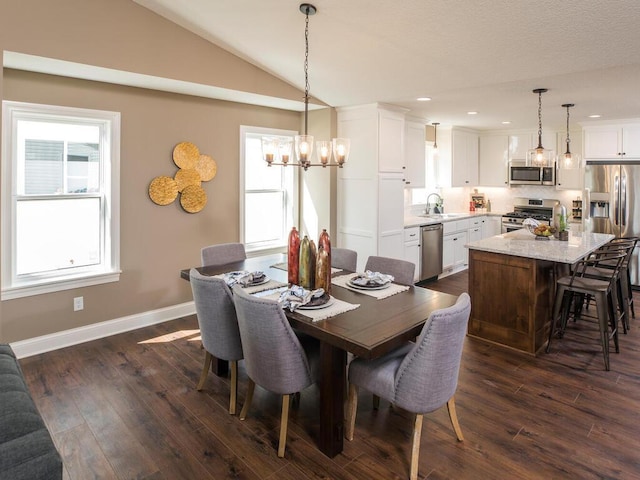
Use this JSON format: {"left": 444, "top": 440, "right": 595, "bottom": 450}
{"left": 336, "top": 104, "right": 405, "bottom": 271}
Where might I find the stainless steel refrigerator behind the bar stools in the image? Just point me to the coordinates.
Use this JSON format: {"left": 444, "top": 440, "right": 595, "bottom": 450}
{"left": 582, "top": 161, "right": 640, "bottom": 287}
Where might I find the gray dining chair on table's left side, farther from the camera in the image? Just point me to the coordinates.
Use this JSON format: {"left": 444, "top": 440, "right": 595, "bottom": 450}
{"left": 189, "top": 268, "right": 243, "bottom": 415}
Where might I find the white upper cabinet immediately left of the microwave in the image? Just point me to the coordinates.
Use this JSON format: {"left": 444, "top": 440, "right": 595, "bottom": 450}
{"left": 478, "top": 135, "right": 509, "bottom": 187}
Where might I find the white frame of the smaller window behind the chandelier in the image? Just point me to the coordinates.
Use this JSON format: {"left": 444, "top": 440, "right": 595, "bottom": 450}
{"left": 239, "top": 125, "right": 299, "bottom": 256}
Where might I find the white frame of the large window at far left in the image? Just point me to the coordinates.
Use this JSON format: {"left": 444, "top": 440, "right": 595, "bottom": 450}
{"left": 0, "top": 101, "right": 120, "bottom": 301}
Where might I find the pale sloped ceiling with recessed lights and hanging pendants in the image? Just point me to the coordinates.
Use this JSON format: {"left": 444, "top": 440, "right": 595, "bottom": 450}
{"left": 134, "top": 0, "right": 640, "bottom": 130}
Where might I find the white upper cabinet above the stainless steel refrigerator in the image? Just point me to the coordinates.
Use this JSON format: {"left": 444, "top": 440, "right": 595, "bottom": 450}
{"left": 584, "top": 123, "right": 640, "bottom": 160}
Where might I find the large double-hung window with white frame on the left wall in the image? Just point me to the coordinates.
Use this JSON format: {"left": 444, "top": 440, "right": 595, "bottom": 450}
{"left": 1, "top": 102, "right": 120, "bottom": 300}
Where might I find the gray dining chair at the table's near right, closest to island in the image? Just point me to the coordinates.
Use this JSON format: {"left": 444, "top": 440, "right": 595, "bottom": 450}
{"left": 345, "top": 293, "right": 471, "bottom": 480}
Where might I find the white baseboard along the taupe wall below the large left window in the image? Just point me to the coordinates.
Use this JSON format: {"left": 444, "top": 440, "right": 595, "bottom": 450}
{"left": 11, "top": 302, "right": 196, "bottom": 358}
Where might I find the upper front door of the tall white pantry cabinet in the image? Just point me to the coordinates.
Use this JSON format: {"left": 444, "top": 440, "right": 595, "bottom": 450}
{"left": 378, "top": 110, "right": 404, "bottom": 173}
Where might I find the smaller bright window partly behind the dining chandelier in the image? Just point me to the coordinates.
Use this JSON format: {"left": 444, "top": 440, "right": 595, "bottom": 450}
{"left": 240, "top": 126, "right": 298, "bottom": 252}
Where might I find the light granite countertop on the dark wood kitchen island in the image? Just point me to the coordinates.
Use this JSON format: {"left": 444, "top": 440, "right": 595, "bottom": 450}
{"left": 465, "top": 228, "right": 614, "bottom": 264}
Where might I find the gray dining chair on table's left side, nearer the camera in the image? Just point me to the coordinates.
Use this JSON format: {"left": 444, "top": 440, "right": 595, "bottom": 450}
{"left": 233, "top": 286, "right": 319, "bottom": 457}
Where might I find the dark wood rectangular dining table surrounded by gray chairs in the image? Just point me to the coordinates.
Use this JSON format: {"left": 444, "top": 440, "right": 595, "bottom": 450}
{"left": 180, "top": 254, "right": 457, "bottom": 457}
